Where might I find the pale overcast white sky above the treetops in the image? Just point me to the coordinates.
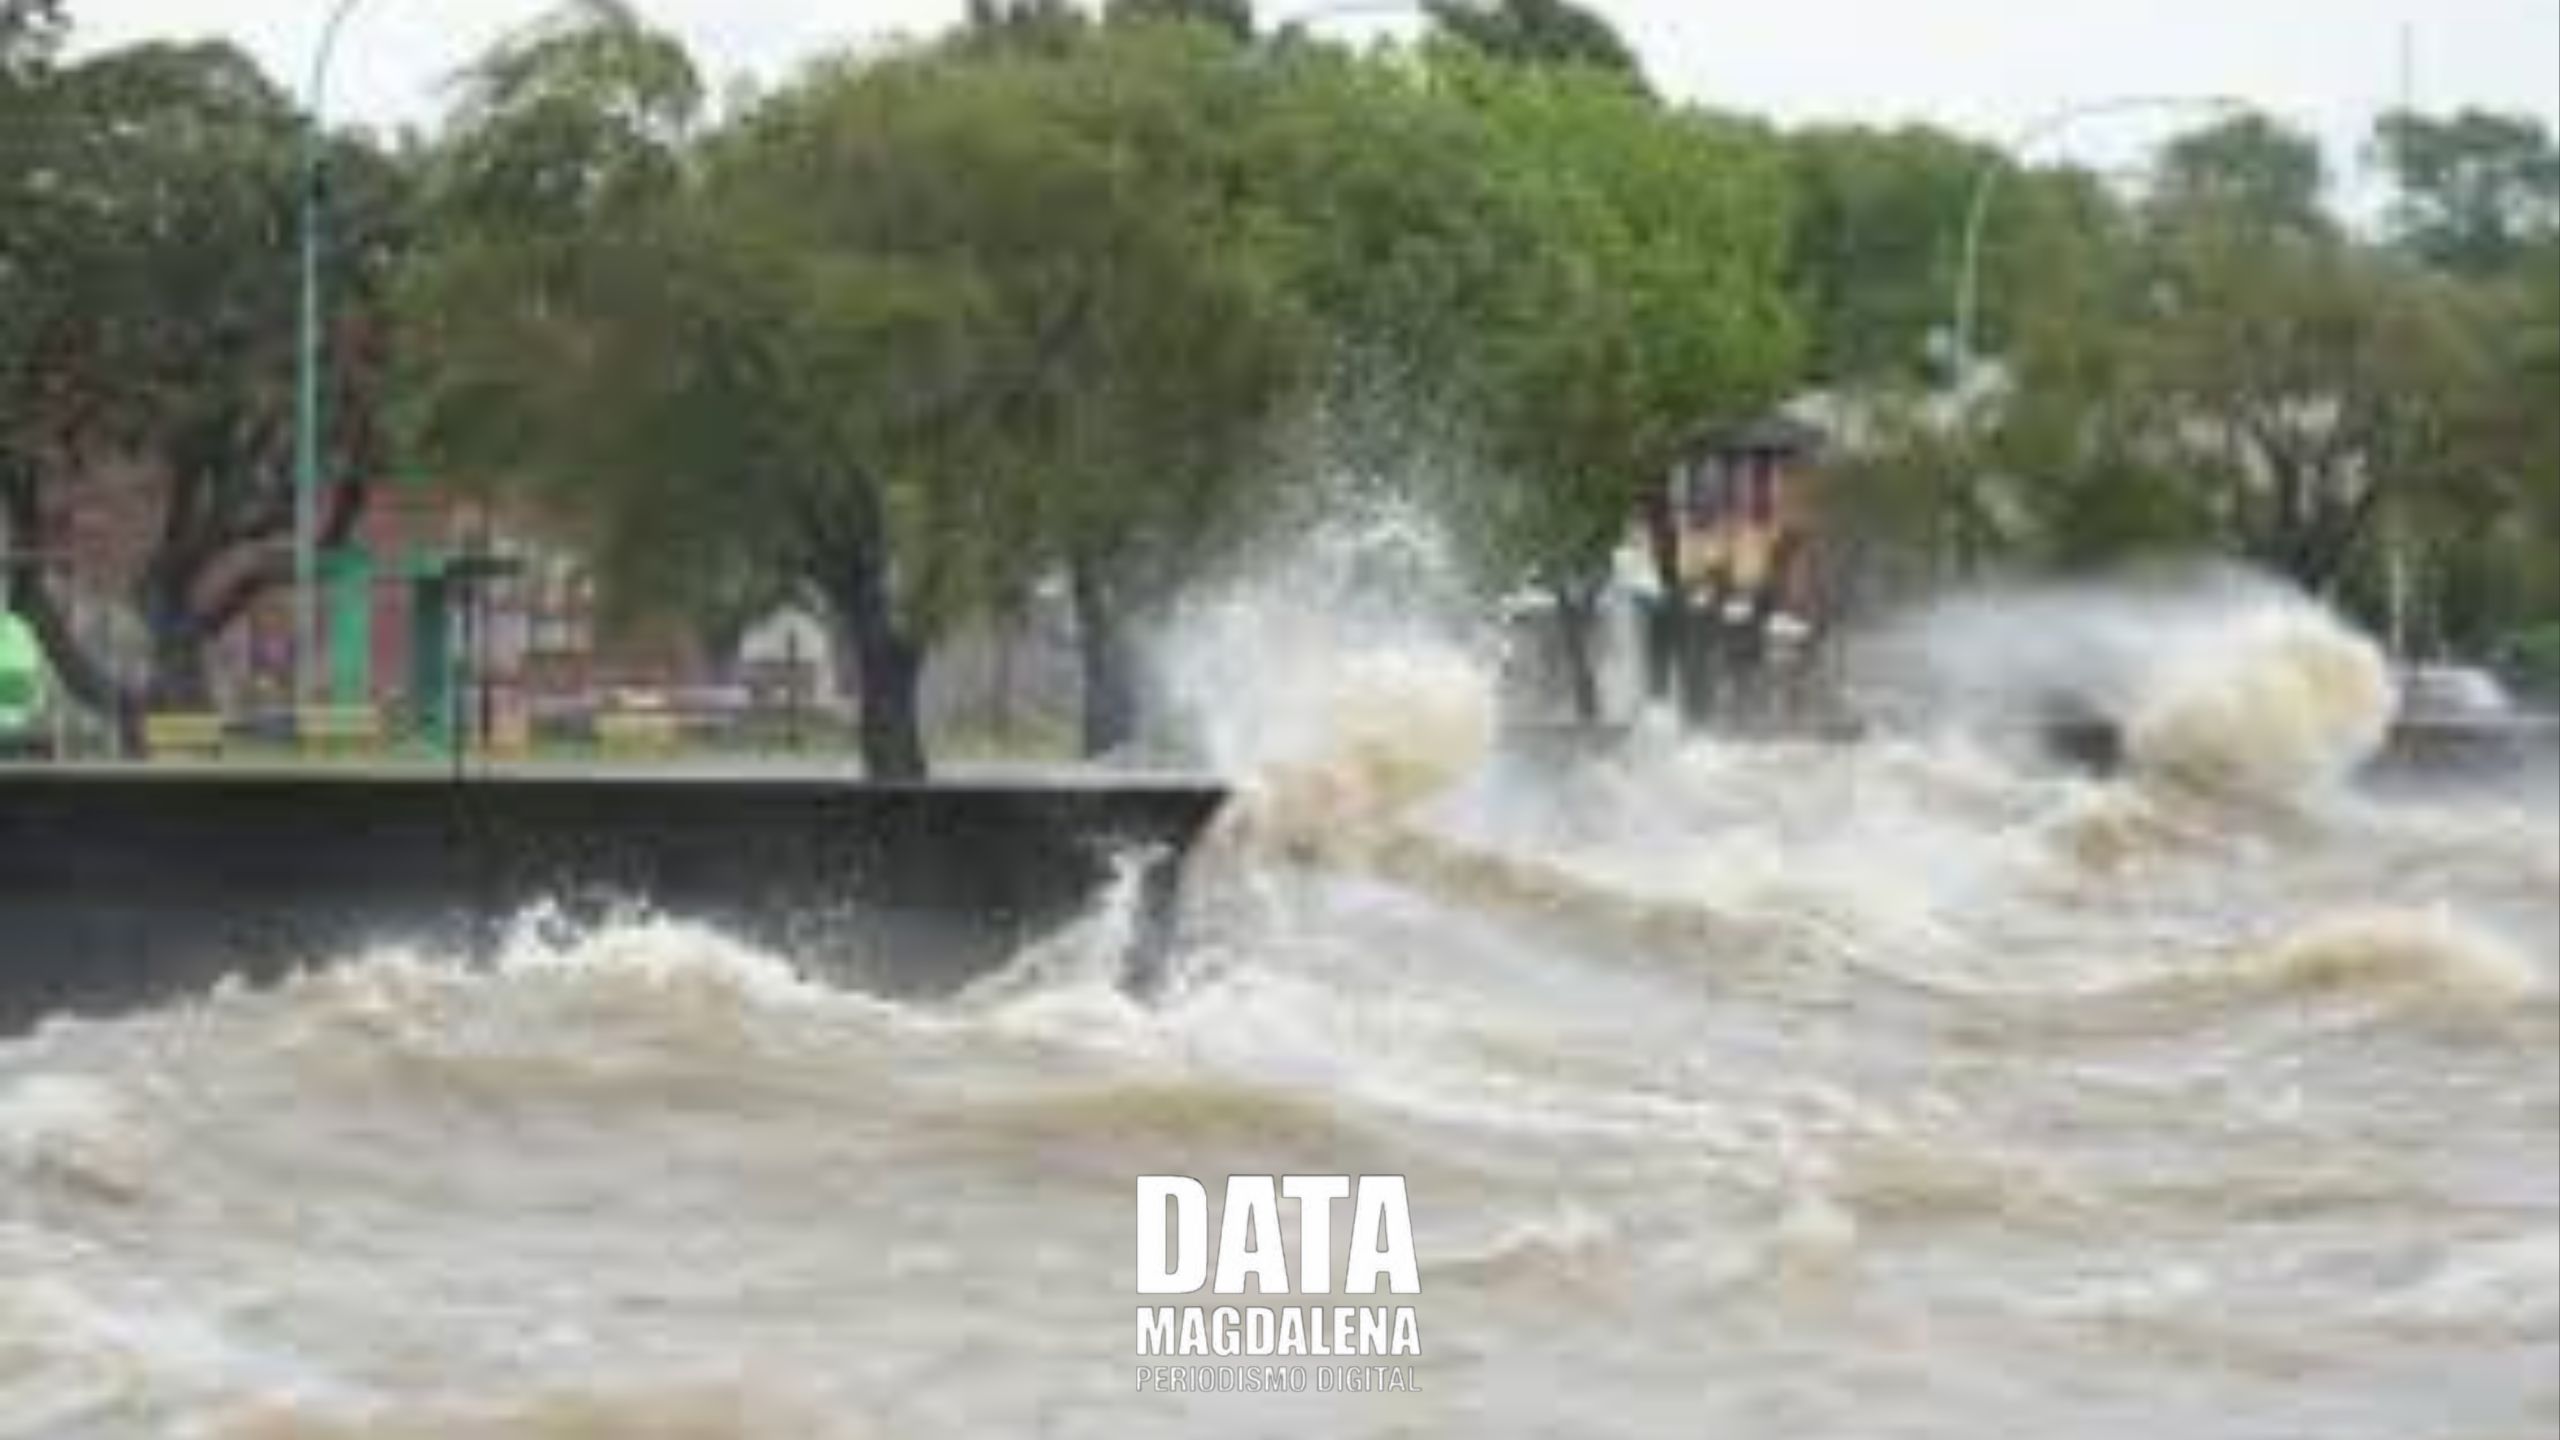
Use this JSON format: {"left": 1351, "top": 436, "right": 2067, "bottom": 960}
{"left": 72, "top": 0, "right": 2560, "bottom": 180}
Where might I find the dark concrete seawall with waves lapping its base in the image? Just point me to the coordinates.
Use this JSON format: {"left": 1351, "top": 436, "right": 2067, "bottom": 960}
{"left": 0, "top": 766, "right": 1224, "bottom": 1035}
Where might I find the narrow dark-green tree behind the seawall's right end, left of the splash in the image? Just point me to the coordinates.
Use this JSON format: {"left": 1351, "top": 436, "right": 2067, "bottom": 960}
{"left": 1009, "top": 26, "right": 1316, "bottom": 753}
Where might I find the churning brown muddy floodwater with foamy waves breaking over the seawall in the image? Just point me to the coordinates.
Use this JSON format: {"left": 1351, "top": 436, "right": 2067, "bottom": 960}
{"left": 0, "top": 586, "right": 2560, "bottom": 1440}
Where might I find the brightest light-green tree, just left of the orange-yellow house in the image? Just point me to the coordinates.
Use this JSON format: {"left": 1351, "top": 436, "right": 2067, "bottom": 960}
{"left": 1457, "top": 67, "right": 1802, "bottom": 715}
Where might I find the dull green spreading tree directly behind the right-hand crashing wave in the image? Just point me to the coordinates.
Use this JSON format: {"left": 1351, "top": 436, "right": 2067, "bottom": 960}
{"left": 1999, "top": 118, "right": 2488, "bottom": 602}
